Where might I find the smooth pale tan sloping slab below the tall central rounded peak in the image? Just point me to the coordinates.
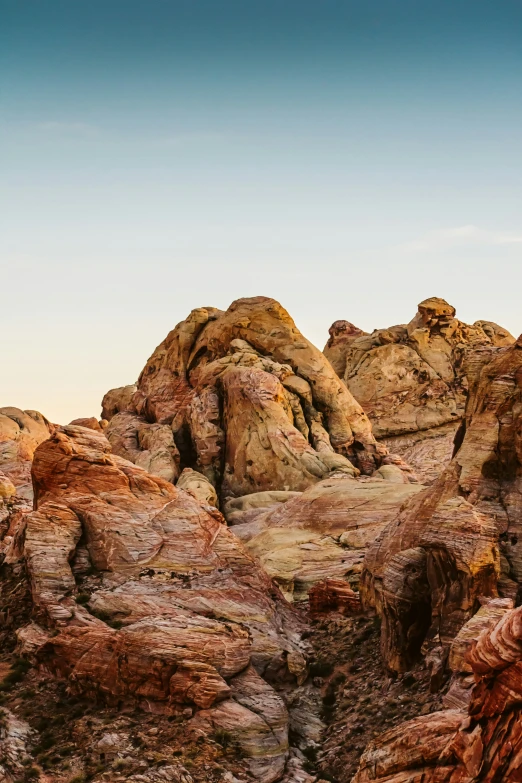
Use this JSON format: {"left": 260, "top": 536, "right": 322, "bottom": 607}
{"left": 233, "top": 474, "right": 422, "bottom": 601}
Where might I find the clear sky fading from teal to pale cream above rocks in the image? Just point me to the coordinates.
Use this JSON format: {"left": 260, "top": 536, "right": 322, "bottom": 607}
{"left": 0, "top": 0, "right": 522, "bottom": 423}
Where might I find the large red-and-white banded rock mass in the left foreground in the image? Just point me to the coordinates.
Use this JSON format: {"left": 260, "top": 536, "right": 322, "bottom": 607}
{"left": 18, "top": 425, "right": 312, "bottom": 783}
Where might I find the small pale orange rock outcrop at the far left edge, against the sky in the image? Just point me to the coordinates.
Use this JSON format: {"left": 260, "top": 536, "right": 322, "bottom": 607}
{"left": 0, "top": 408, "right": 53, "bottom": 503}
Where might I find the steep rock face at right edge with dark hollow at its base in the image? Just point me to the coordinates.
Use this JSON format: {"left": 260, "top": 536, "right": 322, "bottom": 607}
{"left": 362, "top": 339, "right": 522, "bottom": 670}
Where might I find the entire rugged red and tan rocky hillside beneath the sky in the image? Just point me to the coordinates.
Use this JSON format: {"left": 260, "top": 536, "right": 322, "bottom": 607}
{"left": 0, "top": 297, "right": 522, "bottom": 783}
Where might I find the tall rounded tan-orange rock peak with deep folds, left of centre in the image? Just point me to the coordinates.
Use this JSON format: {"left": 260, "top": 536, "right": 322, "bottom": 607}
{"left": 102, "top": 297, "right": 386, "bottom": 499}
